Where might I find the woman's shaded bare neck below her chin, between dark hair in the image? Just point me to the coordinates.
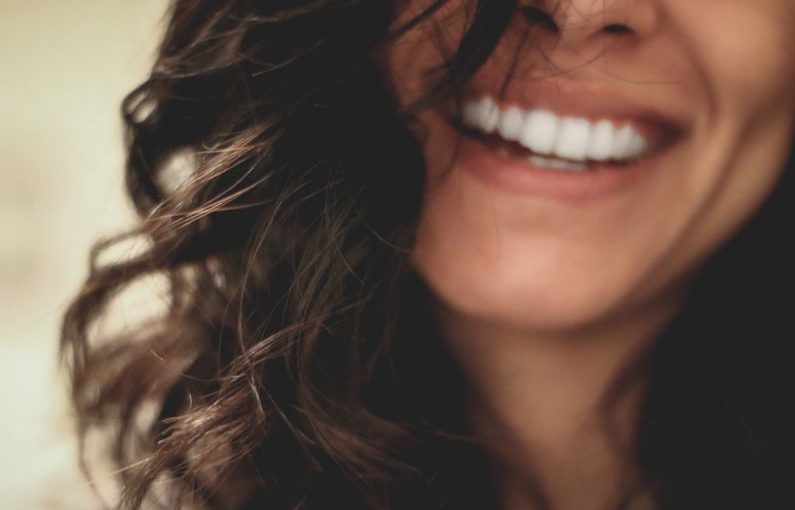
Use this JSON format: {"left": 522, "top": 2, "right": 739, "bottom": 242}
{"left": 438, "top": 294, "right": 677, "bottom": 510}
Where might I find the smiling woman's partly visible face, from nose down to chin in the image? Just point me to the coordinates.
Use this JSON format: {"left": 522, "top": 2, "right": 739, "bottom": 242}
{"left": 387, "top": 0, "right": 795, "bottom": 331}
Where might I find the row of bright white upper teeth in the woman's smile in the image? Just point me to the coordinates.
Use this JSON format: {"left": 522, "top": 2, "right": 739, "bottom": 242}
{"left": 462, "top": 96, "right": 652, "bottom": 161}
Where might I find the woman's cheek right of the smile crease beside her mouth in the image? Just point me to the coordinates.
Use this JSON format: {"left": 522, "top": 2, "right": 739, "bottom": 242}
{"left": 669, "top": 0, "right": 795, "bottom": 266}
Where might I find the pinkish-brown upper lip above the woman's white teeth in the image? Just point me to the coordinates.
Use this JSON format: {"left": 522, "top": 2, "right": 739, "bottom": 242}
{"left": 454, "top": 79, "right": 689, "bottom": 141}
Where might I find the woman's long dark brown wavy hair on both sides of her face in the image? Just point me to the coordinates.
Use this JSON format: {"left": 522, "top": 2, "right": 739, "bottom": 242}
{"left": 61, "top": 0, "right": 795, "bottom": 510}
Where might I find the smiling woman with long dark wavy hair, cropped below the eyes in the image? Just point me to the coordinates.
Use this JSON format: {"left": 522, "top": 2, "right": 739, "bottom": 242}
{"left": 63, "top": 0, "right": 795, "bottom": 510}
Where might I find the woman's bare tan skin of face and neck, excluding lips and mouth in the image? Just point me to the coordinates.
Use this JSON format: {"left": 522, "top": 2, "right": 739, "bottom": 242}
{"left": 386, "top": 0, "right": 795, "bottom": 509}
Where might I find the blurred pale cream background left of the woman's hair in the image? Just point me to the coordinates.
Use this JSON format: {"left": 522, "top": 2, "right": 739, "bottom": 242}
{"left": 0, "top": 0, "right": 167, "bottom": 510}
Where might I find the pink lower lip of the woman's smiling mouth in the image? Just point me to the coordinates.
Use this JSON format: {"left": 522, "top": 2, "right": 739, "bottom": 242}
{"left": 445, "top": 117, "right": 671, "bottom": 202}
